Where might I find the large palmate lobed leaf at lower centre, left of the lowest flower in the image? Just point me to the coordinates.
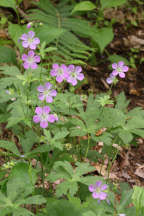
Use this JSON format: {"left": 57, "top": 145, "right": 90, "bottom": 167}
{"left": 48, "top": 161, "right": 97, "bottom": 197}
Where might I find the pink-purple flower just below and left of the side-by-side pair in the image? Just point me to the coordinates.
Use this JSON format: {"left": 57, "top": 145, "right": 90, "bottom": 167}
{"left": 37, "top": 82, "right": 57, "bottom": 103}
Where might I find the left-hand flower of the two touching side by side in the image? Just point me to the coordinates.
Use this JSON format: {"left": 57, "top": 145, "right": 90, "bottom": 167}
{"left": 50, "top": 64, "right": 68, "bottom": 83}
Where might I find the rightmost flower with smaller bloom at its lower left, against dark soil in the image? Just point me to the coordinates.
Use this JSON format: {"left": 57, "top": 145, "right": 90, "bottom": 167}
{"left": 106, "top": 61, "right": 128, "bottom": 84}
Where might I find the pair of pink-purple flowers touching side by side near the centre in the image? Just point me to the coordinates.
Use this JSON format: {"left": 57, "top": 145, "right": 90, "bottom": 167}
{"left": 50, "top": 64, "right": 84, "bottom": 86}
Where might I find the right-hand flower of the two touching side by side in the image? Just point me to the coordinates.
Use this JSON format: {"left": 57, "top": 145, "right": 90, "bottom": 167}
{"left": 66, "top": 65, "right": 84, "bottom": 86}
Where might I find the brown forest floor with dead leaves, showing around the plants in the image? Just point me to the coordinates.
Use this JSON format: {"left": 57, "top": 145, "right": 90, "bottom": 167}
{"left": 0, "top": 1, "right": 144, "bottom": 186}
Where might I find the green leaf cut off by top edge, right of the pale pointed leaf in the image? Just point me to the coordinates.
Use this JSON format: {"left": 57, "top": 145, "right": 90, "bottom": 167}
{"left": 100, "top": 0, "right": 127, "bottom": 10}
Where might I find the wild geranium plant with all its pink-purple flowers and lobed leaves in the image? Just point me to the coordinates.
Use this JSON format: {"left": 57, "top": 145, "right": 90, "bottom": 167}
{"left": 0, "top": 21, "right": 144, "bottom": 216}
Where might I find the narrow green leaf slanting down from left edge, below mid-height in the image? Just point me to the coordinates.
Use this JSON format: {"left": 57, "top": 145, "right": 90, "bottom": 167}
{"left": 0, "top": 140, "right": 20, "bottom": 155}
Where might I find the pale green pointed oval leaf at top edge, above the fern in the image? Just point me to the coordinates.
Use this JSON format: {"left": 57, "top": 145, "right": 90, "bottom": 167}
{"left": 72, "top": 1, "right": 96, "bottom": 14}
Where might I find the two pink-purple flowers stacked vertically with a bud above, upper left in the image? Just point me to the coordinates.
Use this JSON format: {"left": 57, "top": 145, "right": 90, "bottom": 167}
{"left": 20, "top": 23, "right": 40, "bottom": 69}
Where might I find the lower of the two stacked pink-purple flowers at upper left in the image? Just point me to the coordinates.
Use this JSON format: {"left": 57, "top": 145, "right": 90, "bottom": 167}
{"left": 22, "top": 50, "right": 40, "bottom": 69}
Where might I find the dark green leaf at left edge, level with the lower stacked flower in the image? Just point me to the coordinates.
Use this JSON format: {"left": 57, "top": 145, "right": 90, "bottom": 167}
{"left": 0, "top": 46, "right": 16, "bottom": 64}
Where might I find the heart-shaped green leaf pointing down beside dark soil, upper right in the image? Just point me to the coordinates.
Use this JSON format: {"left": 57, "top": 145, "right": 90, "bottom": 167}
{"left": 91, "top": 27, "right": 114, "bottom": 52}
